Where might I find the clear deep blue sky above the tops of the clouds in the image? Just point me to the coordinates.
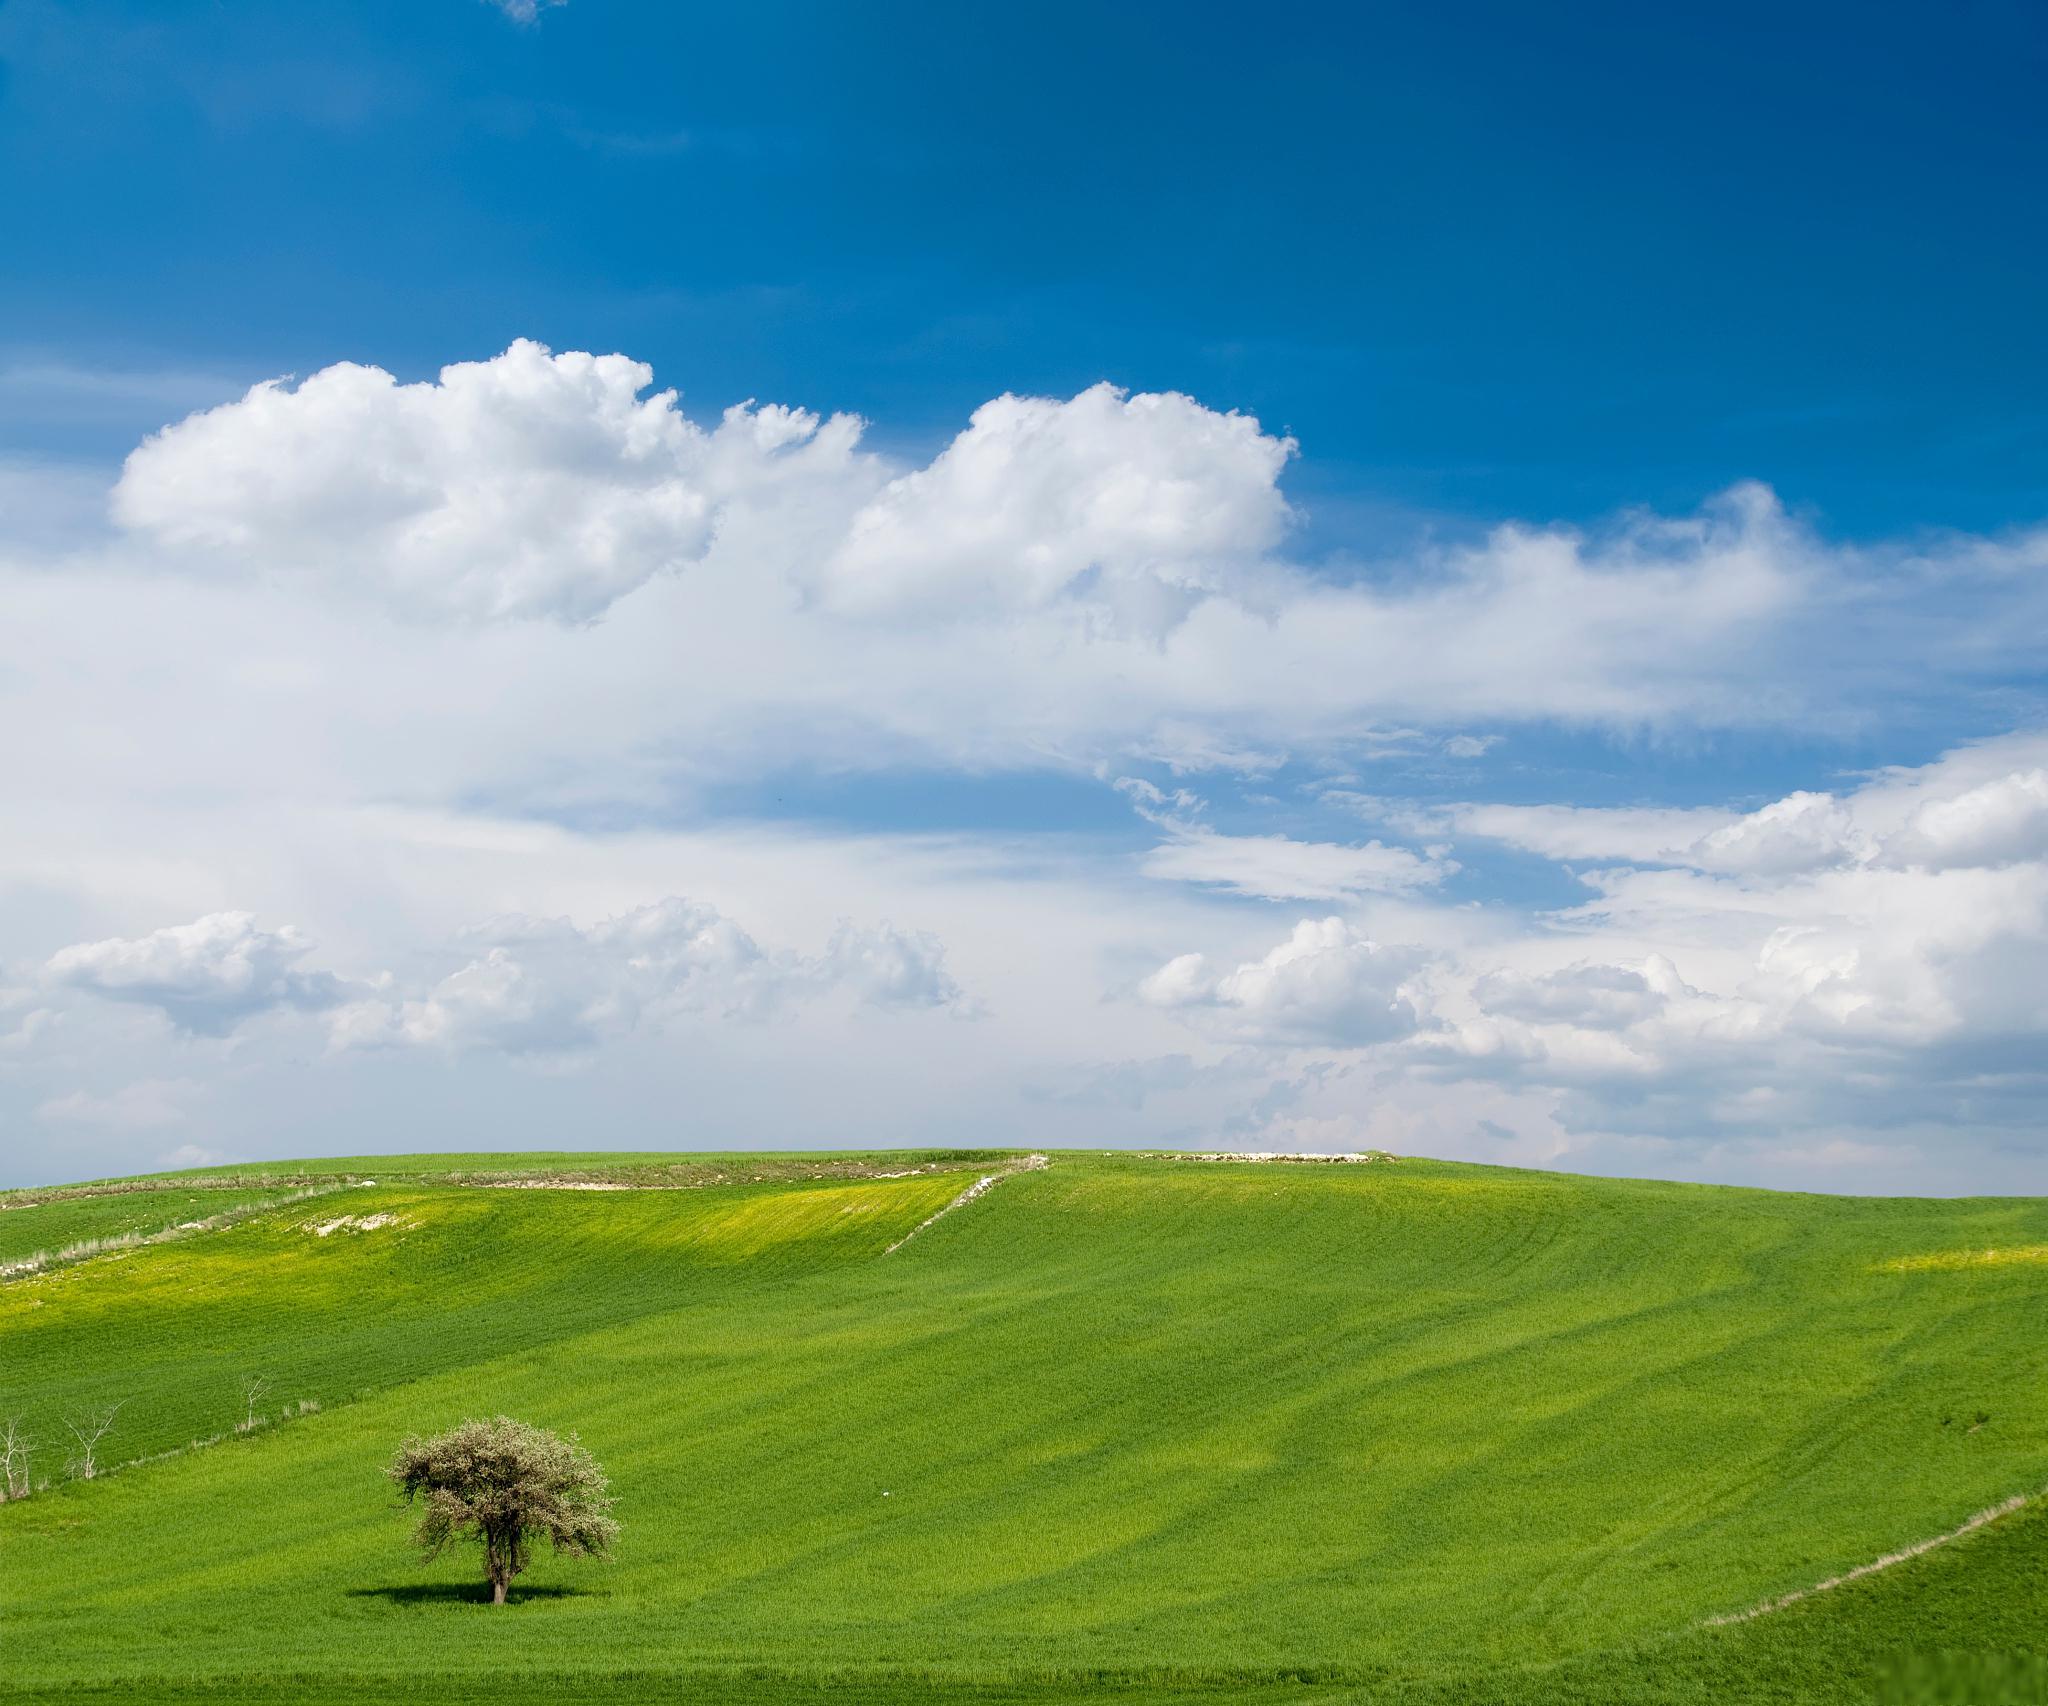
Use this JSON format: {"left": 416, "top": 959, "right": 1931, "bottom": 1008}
{"left": 0, "top": 0, "right": 2048, "bottom": 545}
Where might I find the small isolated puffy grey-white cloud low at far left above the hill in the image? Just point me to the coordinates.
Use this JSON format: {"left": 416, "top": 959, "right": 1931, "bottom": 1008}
{"left": 45, "top": 911, "right": 348, "bottom": 1036}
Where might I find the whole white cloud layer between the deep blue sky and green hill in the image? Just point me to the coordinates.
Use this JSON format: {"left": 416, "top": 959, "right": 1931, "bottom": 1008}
{"left": 0, "top": 342, "right": 2048, "bottom": 1188}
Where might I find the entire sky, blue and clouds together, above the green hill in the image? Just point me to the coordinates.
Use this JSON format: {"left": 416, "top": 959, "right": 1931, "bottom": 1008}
{"left": 0, "top": 0, "right": 2048, "bottom": 1190}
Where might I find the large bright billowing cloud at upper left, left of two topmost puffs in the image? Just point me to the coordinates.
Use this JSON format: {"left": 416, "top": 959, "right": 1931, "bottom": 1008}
{"left": 113, "top": 340, "right": 860, "bottom": 623}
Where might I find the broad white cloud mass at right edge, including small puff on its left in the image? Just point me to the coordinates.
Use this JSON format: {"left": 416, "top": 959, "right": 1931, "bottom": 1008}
{"left": 1139, "top": 737, "right": 2048, "bottom": 1165}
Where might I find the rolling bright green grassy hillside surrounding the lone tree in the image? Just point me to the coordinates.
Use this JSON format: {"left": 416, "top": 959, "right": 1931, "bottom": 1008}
{"left": 0, "top": 1153, "right": 2048, "bottom": 1702}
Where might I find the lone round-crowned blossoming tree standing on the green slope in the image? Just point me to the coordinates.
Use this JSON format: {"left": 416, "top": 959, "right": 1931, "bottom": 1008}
{"left": 389, "top": 1415, "right": 618, "bottom": 1606}
